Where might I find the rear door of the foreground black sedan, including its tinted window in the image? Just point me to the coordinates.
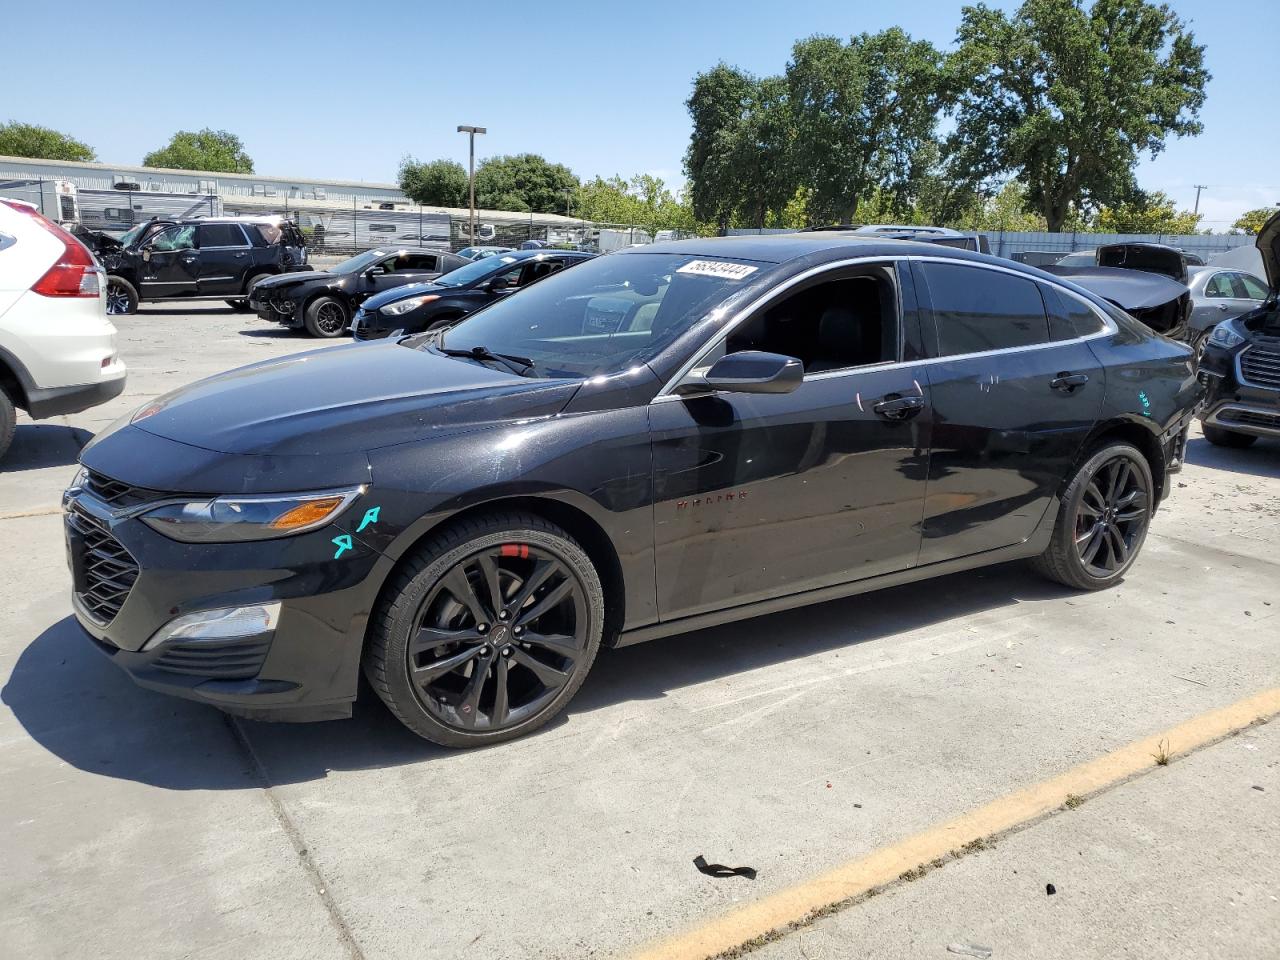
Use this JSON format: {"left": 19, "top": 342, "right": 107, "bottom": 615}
{"left": 913, "top": 259, "right": 1103, "bottom": 564}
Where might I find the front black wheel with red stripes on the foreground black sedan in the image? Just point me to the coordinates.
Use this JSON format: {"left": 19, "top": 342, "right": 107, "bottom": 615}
{"left": 364, "top": 513, "right": 604, "bottom": 748}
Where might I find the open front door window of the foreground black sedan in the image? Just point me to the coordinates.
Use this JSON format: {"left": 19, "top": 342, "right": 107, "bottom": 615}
{"left": 724, "top": 268, "right": 899, "bottom": 374}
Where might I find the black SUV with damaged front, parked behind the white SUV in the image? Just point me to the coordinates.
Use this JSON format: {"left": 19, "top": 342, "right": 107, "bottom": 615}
{"left": 81, "top": 216, "right": 307, "bottom": 314}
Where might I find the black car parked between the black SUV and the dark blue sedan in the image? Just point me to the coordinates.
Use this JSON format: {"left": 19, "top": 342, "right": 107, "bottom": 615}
{"left": 250, "top": 250, "right": 468, "bottom": 338}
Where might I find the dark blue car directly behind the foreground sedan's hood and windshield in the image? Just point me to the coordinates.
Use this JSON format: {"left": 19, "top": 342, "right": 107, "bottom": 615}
{"left": 351, "top": 250, "right": 594, "bottom": 340}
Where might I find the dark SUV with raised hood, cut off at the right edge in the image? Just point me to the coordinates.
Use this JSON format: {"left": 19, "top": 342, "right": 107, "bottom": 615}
{"left": 1199, "top": 212, "right": 1280, "bottom": 447}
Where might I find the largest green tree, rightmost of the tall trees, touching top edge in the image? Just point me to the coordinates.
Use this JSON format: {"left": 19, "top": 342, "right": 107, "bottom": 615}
{"left": 947, "top": 0, "right": 1210, "bottom": 230}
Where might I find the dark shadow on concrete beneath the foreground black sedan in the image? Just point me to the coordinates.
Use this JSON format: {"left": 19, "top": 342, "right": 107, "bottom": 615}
{"left": 0, "top": 564, "right": 1071, "bottom": 790}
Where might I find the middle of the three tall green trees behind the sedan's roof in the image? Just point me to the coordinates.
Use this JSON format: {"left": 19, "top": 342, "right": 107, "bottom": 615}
{"left": 786, "top": 27, "right": 946, "bottom": 221}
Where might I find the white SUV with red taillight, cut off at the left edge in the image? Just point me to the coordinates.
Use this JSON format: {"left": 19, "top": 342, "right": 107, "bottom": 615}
{"left": 0, "top": 200, "right": 124, "bottom": 457}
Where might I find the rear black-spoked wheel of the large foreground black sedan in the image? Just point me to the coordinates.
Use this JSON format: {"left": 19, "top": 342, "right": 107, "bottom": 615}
{"left": 1032, "top": 442, "right": 1156, "bottom": 590}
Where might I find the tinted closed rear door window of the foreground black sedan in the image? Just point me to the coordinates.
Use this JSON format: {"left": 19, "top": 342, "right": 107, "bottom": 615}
{"left": 918, "top": 262, "right": 1050, "bottom": 357}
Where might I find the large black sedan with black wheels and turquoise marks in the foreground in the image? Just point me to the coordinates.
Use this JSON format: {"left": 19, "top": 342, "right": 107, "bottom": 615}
{"left": 64, "top": 233, "right": 1201, "bottom": 746}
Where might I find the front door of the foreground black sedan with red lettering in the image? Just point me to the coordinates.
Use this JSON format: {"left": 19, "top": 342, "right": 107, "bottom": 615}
{"left": 650, "top": 264, "right": 931, "bottom": 621}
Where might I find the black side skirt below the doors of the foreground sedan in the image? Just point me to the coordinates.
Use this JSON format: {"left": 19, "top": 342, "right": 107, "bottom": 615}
{"left": 612, "top": 499, "right": 1061, "bottom": 646}
